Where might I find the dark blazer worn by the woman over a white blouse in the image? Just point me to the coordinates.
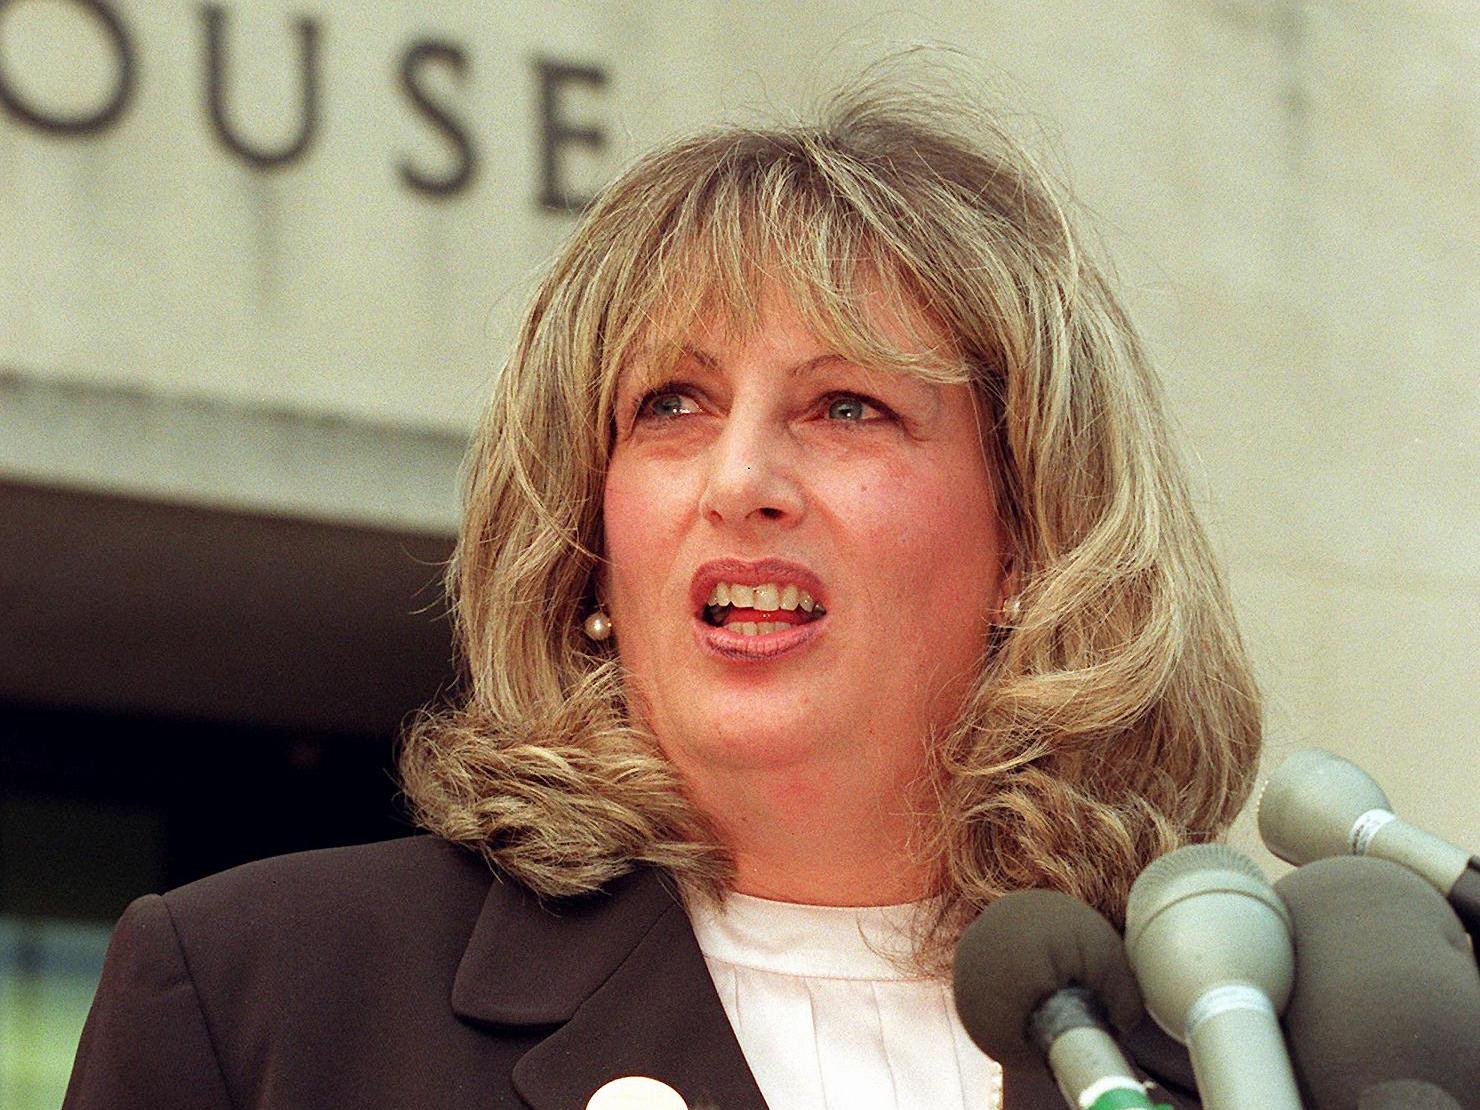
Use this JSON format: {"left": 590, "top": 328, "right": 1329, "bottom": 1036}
{"left": 64, "top": 836, "right": 1190, "bottom": 1110}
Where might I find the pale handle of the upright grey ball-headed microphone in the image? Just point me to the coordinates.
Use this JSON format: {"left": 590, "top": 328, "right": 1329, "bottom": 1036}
{"left": 1187, "top": 986, "right": 1301, "bottom": 1110}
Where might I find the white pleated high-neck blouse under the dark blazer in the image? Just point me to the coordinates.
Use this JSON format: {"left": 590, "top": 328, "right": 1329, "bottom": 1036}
{"left": 690, "top": 894, "right": 1002, "bottom": 1110}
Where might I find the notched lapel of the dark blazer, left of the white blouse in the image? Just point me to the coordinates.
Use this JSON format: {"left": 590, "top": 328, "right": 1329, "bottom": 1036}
{"left": 453, "top": 869, "right": 765, "bottom": 1110}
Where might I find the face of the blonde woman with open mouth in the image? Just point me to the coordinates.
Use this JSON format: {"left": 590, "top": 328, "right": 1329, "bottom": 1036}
{"left": 602, "top": 296, "right": 1003, "bottom": 816}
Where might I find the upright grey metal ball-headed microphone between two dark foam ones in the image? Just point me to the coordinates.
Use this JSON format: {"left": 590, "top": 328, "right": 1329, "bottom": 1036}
{"left": 1125, "top": 844, "right": 1301, "bottom": 1110}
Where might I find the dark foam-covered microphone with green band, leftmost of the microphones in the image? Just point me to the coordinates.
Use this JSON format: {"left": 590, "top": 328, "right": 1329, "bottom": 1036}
{"left": 953, "top": 891, "right": 1165, "bottom": 1110}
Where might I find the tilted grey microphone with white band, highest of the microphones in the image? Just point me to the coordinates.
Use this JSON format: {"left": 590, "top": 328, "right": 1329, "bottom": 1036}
{"left": 1258, "top": 747, "right": 1480, "bottom": 937}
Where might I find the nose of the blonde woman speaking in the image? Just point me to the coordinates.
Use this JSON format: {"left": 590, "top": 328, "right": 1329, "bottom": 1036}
{"left": 699, "top": 417, "right": 805, "bottom": 527}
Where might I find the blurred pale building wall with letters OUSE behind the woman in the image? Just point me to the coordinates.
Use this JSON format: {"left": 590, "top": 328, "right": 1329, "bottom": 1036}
{"left": 0, "top": 0, "right": 1480, "bottom": 1107}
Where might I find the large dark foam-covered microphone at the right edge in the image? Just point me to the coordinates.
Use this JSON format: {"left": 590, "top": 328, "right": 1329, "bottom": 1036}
{"left": 1274, "top": 855, "right": 1480, "bottom": 1110}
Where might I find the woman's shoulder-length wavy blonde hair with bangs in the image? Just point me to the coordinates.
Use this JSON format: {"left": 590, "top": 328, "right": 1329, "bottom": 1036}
{"left": 401, "top": 78, "right": 1259, "bottom": 966}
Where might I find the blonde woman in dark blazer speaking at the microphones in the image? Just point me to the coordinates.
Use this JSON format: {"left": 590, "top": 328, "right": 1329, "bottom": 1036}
{"left": 68, "top": 80, "right": 1259, "bottom": 1110}
